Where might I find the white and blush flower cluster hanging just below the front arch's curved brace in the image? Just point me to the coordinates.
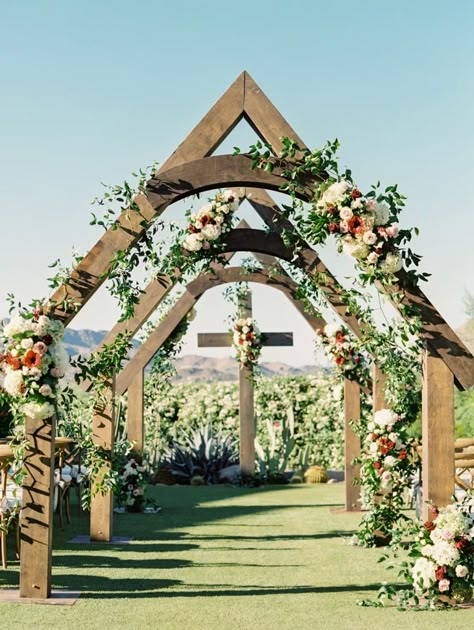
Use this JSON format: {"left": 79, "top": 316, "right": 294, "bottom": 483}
{"left": 182, "top": 190, "right": 239, "bottom": 252}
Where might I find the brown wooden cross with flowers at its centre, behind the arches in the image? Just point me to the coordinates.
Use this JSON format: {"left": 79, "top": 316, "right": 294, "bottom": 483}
{"left": 198, "top": 292, "right": 293, "bottom": 474}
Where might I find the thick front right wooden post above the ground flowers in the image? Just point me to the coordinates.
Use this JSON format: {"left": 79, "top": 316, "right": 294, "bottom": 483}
{"left": 422, "top": 350, "right": 455, "bottom": 520}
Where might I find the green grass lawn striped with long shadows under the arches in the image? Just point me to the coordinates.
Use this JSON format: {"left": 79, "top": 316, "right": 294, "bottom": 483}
{"left": 0, "top": 485, "right": 474, "bottom": 630}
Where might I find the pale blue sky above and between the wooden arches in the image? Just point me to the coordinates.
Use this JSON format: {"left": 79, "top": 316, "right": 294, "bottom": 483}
{"left": 0, "top": 0, "right": 474, "bottom": 363}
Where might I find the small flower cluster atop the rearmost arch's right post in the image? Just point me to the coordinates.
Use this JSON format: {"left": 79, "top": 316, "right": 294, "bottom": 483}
{"left": 316, "top": 324, "right": 368, "bottom": 381}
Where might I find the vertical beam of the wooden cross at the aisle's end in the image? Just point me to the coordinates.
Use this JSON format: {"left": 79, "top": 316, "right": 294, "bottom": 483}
{"left": 239, "top": 291, "right": 255, "bottom": 475}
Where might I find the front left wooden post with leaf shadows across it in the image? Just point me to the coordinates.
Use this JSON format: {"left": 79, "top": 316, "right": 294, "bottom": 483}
{"left": 20, "top": 417, "right": 56, "bottom": 599}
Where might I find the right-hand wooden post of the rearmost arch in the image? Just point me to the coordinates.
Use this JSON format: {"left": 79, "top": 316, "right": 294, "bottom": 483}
{"left": 344, "top": 378, "right": 361, "bottom": 512}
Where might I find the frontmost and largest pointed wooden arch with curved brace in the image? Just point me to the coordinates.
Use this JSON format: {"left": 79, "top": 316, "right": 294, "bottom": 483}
{"left": 16, "top": 72, "right": 474, "bottom": 598}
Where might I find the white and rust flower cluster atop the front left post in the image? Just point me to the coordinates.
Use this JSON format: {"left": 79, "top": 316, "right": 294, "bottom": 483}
{"left": 0, "top": 306, "right": 69, "bottom": 420}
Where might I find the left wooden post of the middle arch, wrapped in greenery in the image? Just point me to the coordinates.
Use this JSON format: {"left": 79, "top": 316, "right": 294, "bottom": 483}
{"left": 90, "top": 378, "right": 115, "bottom": 542}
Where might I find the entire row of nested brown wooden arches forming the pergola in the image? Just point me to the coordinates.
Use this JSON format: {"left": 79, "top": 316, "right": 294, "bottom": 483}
{"left": 16, "top": 72, "right": 474, "bottom": 598}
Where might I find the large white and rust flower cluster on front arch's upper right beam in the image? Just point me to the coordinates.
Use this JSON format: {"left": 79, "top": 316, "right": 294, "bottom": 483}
{"left": 315, "top": 179, "right": 402, "bottom": 275}
